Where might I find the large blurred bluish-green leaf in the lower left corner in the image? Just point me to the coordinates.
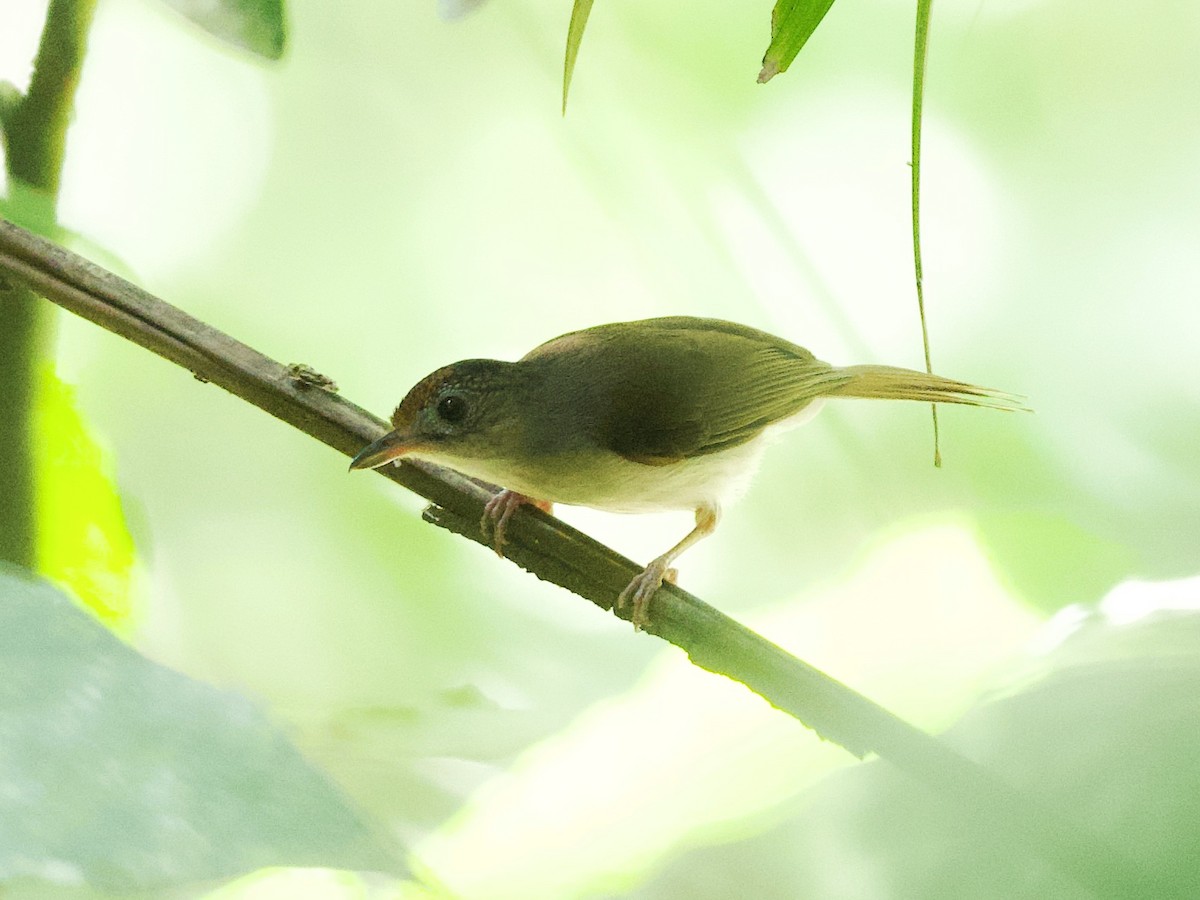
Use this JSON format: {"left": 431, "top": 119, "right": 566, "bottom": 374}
{"left": 0, "top": 566, "right": 403, "bottom": 895}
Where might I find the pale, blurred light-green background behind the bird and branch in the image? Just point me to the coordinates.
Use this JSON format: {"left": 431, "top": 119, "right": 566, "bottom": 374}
{"left": 0, "top": 0, "right": 1200, "bottom": 898}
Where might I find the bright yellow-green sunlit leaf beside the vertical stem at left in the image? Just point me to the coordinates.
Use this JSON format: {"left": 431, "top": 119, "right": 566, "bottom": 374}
{"left": 34, "top": 370, "right": 136, "bottom": 634}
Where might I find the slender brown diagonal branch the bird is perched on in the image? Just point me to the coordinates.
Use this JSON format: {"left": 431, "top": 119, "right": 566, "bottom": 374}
{"left": 0, "top": 220, "right": 1166, "bottom": 896}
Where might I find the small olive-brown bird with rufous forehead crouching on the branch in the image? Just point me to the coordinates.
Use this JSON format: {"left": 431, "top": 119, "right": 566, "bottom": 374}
{"left": 350, "top": 316, "right": 1024, "bottom": 626}
